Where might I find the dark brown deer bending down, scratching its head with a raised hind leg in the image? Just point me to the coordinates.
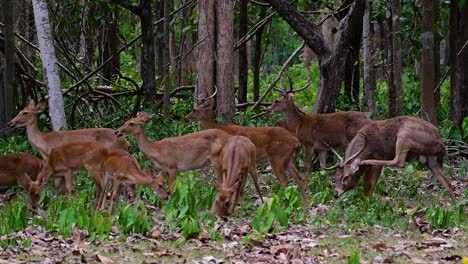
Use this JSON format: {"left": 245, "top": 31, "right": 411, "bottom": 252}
{"left": 327, "top": 116, "right": 456, "bottom": 201}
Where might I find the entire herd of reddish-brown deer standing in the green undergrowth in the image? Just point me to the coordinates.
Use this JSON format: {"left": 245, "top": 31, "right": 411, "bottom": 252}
{"left": 0, "top": 89, "right": 456, "bottom": 218}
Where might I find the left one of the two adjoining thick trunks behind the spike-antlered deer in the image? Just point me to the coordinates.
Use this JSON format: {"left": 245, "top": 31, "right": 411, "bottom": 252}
{"left": 196, "top": 0, "right": 216, "bottom": 98}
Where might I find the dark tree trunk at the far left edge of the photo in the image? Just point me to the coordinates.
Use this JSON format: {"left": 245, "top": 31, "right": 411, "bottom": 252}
{"left": 0, "top": 1, "right": 16, "bottom": 137}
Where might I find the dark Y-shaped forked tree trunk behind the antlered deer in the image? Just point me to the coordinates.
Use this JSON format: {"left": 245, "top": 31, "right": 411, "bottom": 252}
{"left": 268, "top": 0, "right": 366, "bottom": 113}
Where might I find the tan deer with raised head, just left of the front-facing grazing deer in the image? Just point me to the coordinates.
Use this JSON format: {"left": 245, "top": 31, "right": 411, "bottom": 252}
{"left": 115, "top": 113, "right": 230, "bottom": 191}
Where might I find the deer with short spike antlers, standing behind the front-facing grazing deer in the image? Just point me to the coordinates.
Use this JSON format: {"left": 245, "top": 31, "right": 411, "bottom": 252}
{"left": 185, "top": 87, "right": 308, "bottom": 200}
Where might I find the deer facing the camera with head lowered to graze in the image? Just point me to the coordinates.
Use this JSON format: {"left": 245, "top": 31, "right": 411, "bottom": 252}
{"left": 215, "top": 136, "right": 263, "bottom": 217}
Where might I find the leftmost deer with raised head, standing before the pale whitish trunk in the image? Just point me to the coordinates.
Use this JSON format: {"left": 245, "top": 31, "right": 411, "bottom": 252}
{"left": 8, "top": 100, "right": 130, "bottom": 192}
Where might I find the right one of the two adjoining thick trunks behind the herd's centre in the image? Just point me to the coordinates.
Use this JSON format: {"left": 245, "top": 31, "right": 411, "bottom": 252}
{"left": 216, "top": 0, "right": 235, "bottom": 123}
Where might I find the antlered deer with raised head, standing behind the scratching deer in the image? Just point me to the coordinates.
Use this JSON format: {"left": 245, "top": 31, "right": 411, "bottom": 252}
{"left": 268, "top": 89, "right": 371, "bottom": 175}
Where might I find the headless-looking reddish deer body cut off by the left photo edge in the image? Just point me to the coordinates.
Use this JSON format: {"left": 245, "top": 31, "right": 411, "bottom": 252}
{"left": 0, "top": 153, "right": 44, "bottom": 208}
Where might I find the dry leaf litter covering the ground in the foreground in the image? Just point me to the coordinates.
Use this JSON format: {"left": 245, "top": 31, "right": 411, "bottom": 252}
{"left": 0, "top": 164, "right": 468, "bottom": 264}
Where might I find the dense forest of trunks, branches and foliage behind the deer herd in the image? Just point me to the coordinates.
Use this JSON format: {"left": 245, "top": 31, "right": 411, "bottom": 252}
{"left": 0, "top": 0, "right": 468, "bottom": 137}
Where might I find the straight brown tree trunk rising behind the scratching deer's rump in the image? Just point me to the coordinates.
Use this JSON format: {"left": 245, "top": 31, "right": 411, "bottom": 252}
{"left": 421, "top": 0, "right": 437, "bottom": 124}
